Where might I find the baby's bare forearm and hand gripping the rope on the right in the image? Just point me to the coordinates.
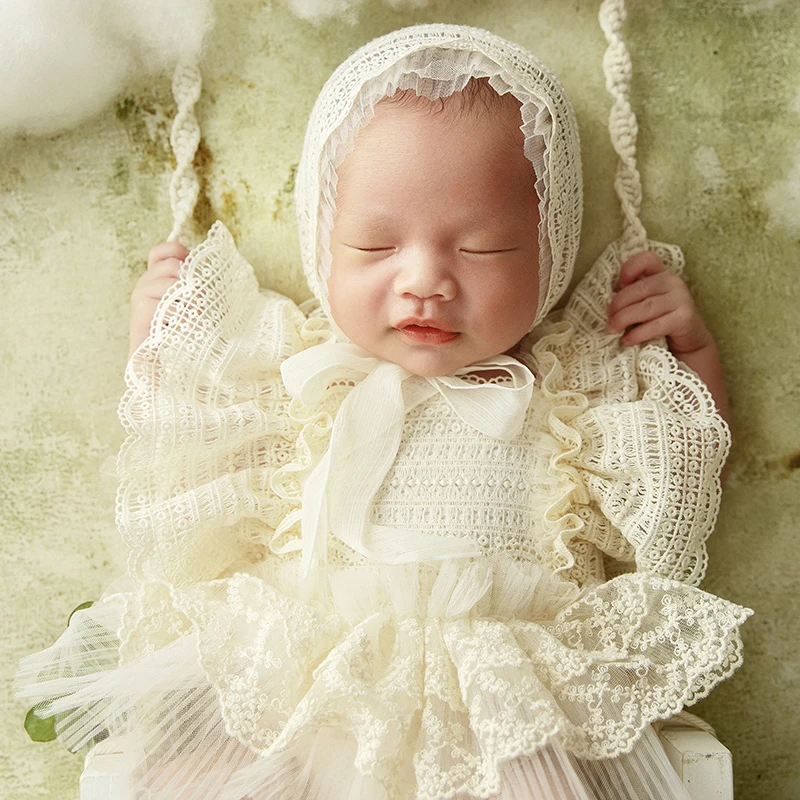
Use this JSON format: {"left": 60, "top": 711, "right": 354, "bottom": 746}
{"left": 607, "top": 252, "right": 728, "bottom": 422}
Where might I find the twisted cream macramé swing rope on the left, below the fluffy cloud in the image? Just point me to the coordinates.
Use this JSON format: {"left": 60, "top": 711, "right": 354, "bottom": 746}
{"left": 167, "top": 61, "right": 202, "bottom": 246}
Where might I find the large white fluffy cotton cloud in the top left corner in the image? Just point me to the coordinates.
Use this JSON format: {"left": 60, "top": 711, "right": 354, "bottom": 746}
{"left": 0, "top": 0, "right": 213, "bottom": 135}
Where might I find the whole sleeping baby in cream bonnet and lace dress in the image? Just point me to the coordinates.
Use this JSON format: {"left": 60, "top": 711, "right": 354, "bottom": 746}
{"left": 27, "top": 25, "right": 749, "bottom": 800}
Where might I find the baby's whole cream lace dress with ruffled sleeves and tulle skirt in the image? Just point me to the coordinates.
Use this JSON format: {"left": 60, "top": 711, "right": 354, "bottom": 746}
{"left": 18, "top": 20, "right": 750, "bottom": 800}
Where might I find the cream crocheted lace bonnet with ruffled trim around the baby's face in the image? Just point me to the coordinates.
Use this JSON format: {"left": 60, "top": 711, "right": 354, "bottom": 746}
{"left": 295, "top": 24, "right": 583, "bottom": 340}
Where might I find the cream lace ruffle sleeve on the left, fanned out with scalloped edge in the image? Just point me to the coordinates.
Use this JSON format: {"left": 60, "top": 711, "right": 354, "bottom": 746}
{"left": 117, "top": 223, "right": 332, "bottom": 586}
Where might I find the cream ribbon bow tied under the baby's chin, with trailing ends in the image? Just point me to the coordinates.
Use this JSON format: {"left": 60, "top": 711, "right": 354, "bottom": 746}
{"left": 273, "top": 342, "right": 534, "bottom": 575}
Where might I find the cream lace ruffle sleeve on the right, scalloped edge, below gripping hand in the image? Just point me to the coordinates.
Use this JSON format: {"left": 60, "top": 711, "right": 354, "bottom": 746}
{"left": 531, "top": 242, "right": 730, "bottom": 585}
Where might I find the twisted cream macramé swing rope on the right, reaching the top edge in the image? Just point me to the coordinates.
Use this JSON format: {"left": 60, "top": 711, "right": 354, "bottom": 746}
{"left": 599, "top": 0, "right": 647, "bottom": 261}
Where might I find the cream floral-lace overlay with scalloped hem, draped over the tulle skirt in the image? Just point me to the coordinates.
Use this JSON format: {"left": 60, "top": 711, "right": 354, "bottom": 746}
{"left": 103, "top": 557, "right": 746, "bottom": 798}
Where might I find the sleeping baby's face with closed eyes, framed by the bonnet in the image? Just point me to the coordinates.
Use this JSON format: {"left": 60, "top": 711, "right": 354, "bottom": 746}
{"left": 328, "top": 89, "right": 539, "bottom": 376}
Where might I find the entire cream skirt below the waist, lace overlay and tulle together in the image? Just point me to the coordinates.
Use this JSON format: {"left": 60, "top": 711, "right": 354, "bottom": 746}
{"left": 17, "top": 557, "right": 748, "bottom": 800}
